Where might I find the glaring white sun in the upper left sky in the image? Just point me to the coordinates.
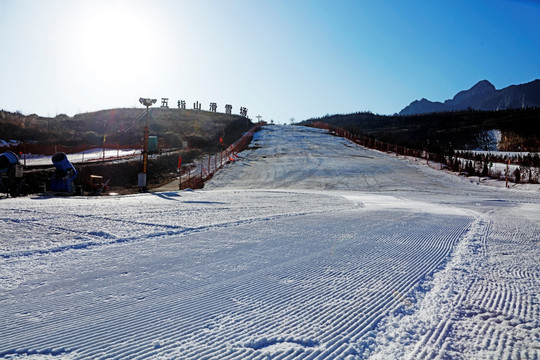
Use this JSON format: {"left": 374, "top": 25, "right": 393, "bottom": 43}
{"left": 67, "top": 1, "right": 160, "bottom": 86}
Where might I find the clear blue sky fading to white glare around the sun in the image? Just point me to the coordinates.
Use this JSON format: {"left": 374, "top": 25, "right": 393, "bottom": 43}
{"left": 0, "top": 0, "right": 540, "bottom": 123}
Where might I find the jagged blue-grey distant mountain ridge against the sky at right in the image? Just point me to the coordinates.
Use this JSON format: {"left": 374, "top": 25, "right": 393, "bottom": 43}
{"left": 399, "top": 79, "right": 540, "bottom": 115}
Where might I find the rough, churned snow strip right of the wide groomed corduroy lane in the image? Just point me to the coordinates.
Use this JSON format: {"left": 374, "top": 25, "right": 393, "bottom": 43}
{"left": 376, "top": 207, "right": 540, "bottom": 359}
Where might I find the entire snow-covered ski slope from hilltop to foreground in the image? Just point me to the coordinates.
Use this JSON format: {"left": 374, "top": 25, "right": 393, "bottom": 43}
{"left": 0, "top": 126, "right": 540, "bottom": 359}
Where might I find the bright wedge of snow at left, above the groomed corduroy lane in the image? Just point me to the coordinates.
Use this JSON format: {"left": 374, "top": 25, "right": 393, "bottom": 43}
{"left": 0, "top": 191, "right": 352, "bottom": 256}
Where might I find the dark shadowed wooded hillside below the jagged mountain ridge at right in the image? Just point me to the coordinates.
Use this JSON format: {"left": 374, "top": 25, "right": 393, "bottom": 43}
{"left": 300, "top": 108, "right": 540, "bottom": 152}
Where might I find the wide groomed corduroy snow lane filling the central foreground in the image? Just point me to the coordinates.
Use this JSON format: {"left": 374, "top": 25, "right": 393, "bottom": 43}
{"left": 0, "top": 209, "right": 470, "bottom": 359}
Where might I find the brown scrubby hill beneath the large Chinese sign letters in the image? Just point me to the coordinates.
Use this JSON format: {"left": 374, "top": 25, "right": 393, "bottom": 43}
{"left": 0, "top": 108, "right": 252, "bottom": 150}
